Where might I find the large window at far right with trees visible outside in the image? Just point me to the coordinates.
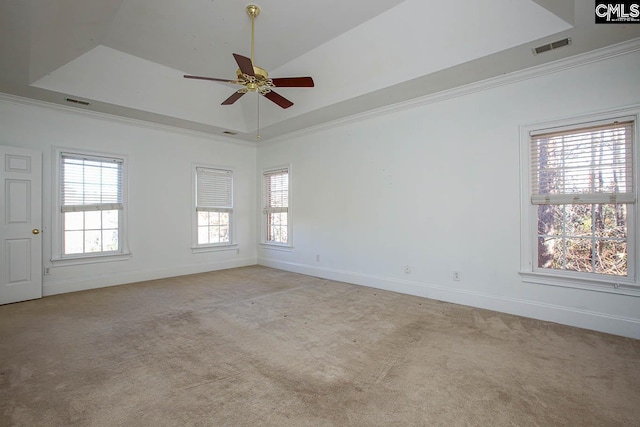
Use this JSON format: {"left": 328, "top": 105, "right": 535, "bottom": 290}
{"left": 523, "top": 111, "right": 637, "bottom": 289}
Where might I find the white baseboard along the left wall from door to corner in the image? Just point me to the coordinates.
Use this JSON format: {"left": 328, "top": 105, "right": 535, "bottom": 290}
{"left": 42, "top": 258, "right": 256, "bottom": 296}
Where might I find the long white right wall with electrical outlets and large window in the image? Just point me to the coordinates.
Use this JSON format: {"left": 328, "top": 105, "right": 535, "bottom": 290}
{"left": 258, "top": 51, "right": 640, "bottom": 338}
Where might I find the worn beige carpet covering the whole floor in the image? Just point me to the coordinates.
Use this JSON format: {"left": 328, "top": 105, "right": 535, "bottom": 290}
{"left": 0, "top": 266, "right": 640, "bottom": 426}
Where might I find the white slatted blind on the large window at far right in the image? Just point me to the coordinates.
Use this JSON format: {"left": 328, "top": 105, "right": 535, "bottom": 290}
{"left": 530, "top": 121, "right": 635, "bottom": 205}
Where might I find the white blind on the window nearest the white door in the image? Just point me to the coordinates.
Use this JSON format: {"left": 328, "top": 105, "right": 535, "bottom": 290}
{"left": 60, "top": 153, "right": 123, "bottom": 212}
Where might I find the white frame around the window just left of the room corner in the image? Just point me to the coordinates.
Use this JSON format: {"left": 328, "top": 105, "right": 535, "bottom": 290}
{"left": 191, "top": 163, "right": 238, "bottom": 253}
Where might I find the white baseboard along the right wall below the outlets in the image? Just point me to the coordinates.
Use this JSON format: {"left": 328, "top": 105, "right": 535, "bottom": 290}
{"left": 258, "top": 258, "right": 640, "bottom": 339}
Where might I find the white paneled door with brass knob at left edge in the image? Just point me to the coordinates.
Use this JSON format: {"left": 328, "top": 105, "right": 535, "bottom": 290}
{"left": 0, "top": 146, "right": 42, "bottom": 304}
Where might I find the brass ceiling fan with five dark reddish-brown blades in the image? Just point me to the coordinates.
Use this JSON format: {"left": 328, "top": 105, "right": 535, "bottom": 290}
{"left": 184, "top": 4, "right": 314, "bottom": 108}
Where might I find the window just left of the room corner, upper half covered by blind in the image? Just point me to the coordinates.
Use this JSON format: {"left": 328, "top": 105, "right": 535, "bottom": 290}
{"left": 196, "top": 166, "right": 233, "bottom": 246}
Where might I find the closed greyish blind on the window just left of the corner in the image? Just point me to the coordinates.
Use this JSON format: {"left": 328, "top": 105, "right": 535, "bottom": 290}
{"left": 196, "top": 167, "right": 233, "bottom": 212}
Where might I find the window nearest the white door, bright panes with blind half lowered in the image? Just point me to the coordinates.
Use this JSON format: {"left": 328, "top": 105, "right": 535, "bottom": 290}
{"left": 59, "top": 152, "right": 124, "bottom": 258}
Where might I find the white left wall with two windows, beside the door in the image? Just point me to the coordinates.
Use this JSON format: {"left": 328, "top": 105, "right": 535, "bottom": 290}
{"left": 0, "top": 97, "right": 257, "bottom": 295}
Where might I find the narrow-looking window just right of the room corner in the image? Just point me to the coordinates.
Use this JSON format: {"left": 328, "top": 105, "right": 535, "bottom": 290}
{"left": 263, "top": 168, "right": 291, "bottom": 245}
